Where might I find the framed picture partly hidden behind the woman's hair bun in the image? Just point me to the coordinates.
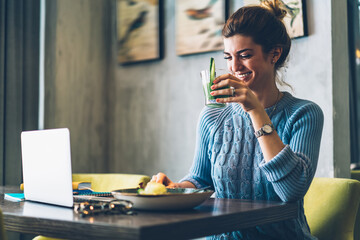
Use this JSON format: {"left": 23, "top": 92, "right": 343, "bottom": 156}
{"left": 244, "top": 0, "right": 308, "bottom": 38}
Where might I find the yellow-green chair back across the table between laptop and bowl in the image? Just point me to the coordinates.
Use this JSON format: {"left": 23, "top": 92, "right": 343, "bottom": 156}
{"left": 72, "top": 173, "right": 150, "bottom": 192}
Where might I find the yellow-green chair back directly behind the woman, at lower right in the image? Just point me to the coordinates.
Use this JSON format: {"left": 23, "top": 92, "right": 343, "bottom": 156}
{"left": 304, "top": 178, "right": 360, "bottom": 240}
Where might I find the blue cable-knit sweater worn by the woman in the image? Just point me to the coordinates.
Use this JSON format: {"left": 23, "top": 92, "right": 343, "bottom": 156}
{"left": 181, "top": 92, "right": 323, "bottom": 240}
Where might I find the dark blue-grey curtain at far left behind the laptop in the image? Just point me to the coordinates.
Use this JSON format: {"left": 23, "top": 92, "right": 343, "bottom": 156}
{"left": 0, "top": 0, "right": 40, "bottom": 185}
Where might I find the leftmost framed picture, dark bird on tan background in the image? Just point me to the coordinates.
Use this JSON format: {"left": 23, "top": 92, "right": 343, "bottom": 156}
{"left": 117, "top": 0, "right": 161, "bottom": 64}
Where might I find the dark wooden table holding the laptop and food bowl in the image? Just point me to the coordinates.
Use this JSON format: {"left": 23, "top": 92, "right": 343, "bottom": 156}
{"left": 0, "top": 187, "right": 297, "bottom": 240}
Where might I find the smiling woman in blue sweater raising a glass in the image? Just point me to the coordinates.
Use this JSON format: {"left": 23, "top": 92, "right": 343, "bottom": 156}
{"left": 153, "top": 0, "right": 323, "bottom": 240}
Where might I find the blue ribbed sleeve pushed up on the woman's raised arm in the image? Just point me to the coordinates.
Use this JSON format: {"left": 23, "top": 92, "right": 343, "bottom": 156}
{"left": 260, "top": 102, "right": 324, "bottom": 202}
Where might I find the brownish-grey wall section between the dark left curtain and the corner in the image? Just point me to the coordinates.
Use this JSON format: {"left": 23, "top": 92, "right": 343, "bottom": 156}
{"left": 45, "top": 0, "right": 110, "bottom": 172}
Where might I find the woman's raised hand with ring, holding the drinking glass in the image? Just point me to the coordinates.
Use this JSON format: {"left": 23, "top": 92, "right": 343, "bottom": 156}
{"left": 210, "top": 73, "right": 263, "bottom": 112}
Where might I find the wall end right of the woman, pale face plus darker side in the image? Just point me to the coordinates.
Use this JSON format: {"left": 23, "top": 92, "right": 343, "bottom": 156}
{"left": 287, "top": 0, "right": 350, "bottom": 177}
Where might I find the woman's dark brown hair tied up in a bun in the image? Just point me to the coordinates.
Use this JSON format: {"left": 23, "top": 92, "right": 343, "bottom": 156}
{"left": 222, "top": 0, "right": 291, "bottom": 70}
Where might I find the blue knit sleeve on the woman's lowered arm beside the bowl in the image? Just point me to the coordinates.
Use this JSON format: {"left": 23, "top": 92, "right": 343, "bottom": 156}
{"left": 180, "top": 107, "right": 222, "bottom": 188}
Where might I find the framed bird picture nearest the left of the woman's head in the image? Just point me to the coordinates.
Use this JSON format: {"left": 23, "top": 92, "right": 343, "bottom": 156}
{"left": 175, "top": 0, "right": 227, "bottom": 55}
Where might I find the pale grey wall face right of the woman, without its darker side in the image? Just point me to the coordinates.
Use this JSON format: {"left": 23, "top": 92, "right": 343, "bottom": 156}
{"left": 287, "top": 0, "right": 334, "bottom": 177}
